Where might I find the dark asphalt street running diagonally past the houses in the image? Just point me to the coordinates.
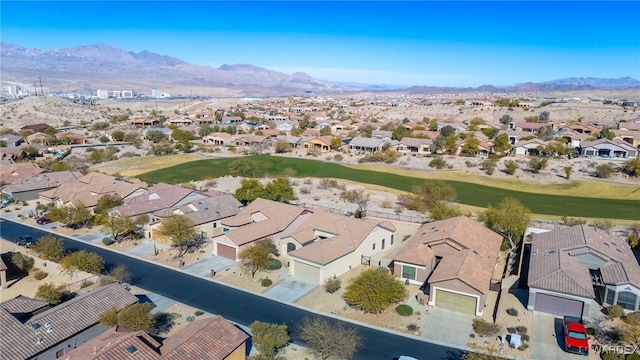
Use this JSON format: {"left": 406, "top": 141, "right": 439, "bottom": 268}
{"left": 0, "top": 219, "right": 468, "bottom": 360}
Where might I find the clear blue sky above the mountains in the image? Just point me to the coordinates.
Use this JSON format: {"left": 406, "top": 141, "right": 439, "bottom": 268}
{"left": 0, "top": 0, "right": 640, "bottom": 86}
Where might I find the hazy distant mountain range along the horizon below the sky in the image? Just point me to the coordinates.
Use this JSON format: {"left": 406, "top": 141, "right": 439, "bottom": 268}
{"left": 0, "top": 43, "right": 640, "bottom": 96}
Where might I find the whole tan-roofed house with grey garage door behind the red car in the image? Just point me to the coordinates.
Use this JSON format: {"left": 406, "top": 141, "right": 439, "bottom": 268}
{"left": 525, "top": 225, "right": 640, "bottom": 318}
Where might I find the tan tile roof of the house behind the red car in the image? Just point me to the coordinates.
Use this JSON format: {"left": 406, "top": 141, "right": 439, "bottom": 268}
{"left": 529, "top": 225, "right": 640, "bottom": 298}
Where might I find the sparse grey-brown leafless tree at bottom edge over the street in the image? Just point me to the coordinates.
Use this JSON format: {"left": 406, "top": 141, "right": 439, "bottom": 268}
{"left": 300, "top": 317, "right": 362, "bottom": 360}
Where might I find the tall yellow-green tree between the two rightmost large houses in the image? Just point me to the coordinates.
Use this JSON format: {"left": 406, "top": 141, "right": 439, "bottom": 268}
{"left": 479, "top": 197, "right": 531, "bottom": 250}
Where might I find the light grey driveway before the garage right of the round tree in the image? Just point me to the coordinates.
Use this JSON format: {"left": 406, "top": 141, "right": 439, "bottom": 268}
{"left": 421, "top": 308, "right": 474, "bottom": 349}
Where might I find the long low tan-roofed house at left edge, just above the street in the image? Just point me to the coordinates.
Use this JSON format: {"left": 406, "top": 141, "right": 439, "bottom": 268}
{"left": 2, "top": 171, "right": 82, "bottom": 201}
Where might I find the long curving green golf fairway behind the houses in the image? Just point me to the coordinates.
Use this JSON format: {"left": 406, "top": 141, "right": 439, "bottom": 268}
{"left": 138, "top": 156, "right": 640, "bottom": 220}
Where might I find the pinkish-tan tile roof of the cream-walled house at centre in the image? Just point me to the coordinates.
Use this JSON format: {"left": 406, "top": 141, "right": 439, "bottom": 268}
{"left": 289, "top": 210, "right": 395, "bottom": 265}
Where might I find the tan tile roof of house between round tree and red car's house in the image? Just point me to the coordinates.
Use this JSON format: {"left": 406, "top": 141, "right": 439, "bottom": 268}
{"left": 393, "top": 216, "right": 502, "bottom": 294}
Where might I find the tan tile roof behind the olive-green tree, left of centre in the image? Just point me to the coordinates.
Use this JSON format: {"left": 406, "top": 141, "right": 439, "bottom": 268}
{"left": 153, "top": 193, "right": 242, "bottom": 225}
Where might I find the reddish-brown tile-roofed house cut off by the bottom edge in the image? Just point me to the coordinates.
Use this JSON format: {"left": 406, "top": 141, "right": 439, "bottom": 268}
{"left": 65, "top": 316, "right": 249, "bottom": 360}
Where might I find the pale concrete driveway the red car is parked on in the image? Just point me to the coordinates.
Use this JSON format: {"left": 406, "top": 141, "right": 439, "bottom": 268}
{"left": 531, "top": 312, "right": 591, "bottom": 360}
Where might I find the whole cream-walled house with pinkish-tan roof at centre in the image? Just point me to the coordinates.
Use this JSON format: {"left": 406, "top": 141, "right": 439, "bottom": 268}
{"left": 280, "top": 210, "right": 396, "bottom": 284}
